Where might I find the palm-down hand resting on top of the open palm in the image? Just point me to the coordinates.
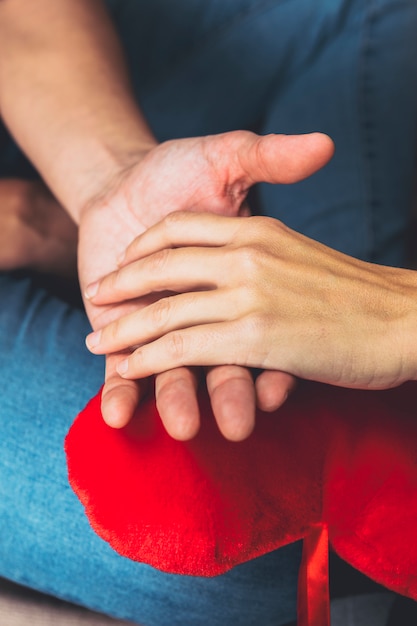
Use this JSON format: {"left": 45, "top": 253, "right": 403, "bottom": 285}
{"left": 87, "top": 213, "right": 417, "bottom": 389}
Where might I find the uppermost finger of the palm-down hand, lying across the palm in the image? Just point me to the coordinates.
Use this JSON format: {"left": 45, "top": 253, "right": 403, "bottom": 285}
{"left": 119, "top": 211, "right": 240, "bottom": 267}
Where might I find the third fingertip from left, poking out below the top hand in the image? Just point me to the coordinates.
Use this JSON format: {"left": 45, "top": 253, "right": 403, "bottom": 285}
{"left": 207, "top": 365, "right": 256, "bottom": 441}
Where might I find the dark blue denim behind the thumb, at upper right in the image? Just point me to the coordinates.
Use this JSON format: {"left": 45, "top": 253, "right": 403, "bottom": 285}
{"left": 108, "top": 0, "right": 417, "bottom": 265}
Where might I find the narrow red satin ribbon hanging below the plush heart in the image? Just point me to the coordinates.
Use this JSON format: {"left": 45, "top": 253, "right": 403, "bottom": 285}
{"left": 298, "top": 525, "right": 330, "bottom": 626}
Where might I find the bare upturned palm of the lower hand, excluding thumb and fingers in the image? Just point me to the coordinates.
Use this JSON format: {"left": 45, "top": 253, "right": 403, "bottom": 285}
{"left": 79, "top": 133, "right": 249, "bottom": 302}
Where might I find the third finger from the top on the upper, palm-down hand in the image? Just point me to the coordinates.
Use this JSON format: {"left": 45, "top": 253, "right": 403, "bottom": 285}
{"left": 86, "top": 290, "right": 237, "bottom": 354}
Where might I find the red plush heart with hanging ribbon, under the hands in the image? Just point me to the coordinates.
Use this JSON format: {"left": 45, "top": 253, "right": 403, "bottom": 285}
{"left": 65, "top": 383, "right": 417, "bottom": 626}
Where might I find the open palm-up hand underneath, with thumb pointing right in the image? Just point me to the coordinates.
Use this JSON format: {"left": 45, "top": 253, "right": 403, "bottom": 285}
{"left": 79, "top": 131, "right": 333, "bottom": 439}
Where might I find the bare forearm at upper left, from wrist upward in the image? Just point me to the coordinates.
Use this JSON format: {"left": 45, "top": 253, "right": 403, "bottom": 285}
{"left": 0, "top": 0, "right": 154, "bottom": 222}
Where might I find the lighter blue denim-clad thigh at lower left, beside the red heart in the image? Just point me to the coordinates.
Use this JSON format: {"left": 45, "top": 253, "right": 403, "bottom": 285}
{"left": 0, "top": 274, "right": 300, "bottom": 626}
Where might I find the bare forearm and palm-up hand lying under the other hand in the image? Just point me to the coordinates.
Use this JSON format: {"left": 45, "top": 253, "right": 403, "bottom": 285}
{"left": 0, "top": 0, "right": 333, "bottom": 439}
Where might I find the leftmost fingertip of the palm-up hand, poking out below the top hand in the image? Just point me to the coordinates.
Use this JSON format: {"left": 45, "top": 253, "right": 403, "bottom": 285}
{"left": 101, "top": 354, "right": 148, "bottom": 428}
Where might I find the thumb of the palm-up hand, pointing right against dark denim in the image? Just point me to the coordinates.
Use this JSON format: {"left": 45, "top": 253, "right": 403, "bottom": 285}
{"left": 229, "top": 133, "right": 334, "bottom": 186}
